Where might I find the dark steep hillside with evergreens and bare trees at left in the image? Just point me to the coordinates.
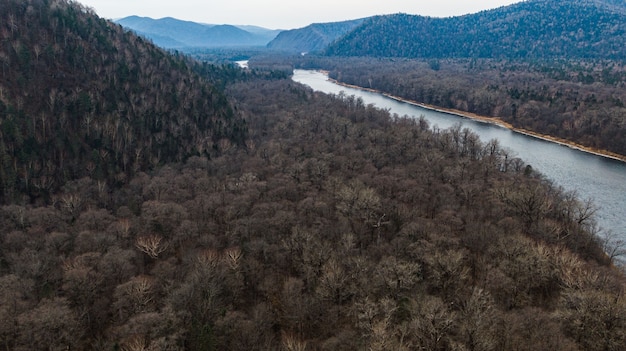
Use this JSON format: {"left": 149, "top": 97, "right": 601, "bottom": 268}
{"left": 0, "top": 0, "right": 245, "bottom": 203}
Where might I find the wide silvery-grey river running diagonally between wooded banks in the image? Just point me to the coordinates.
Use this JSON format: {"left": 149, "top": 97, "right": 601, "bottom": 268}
{"left": 292, "top": 70, "right": 626, "bottom": 241}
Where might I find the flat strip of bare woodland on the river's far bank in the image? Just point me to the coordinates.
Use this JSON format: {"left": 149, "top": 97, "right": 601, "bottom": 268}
{"left": 270, "top": 56, "right": 626, "bottom": 157}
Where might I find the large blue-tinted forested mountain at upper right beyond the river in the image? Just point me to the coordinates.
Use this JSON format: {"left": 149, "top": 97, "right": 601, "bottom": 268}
{"left": 325, "top": 0, "right": 626, "bottom": 60}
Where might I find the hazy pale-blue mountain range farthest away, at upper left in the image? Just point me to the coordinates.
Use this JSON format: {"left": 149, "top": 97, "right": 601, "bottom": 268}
{"left": 116, "top": 16, "right": 280, "bottom": 49}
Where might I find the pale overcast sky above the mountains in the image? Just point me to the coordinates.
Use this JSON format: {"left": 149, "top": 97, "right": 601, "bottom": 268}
{"left": 78, "top": 0, "right": 521, "bottom": 29}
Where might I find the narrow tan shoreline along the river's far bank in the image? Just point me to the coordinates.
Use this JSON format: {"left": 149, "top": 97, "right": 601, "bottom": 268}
{"left": 319, "top": 74, "right": 626, "bottom": 163}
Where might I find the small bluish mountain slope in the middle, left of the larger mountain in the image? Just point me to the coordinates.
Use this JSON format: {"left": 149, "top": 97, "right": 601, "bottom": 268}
{"left": 267, "top": 19, "right": 365, "bottom": 52}
